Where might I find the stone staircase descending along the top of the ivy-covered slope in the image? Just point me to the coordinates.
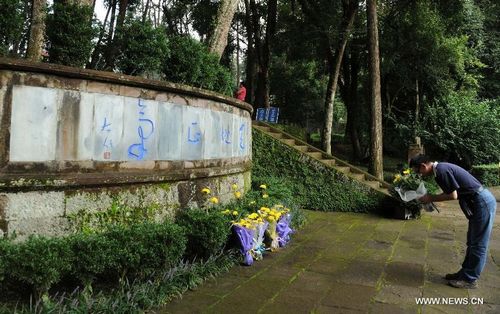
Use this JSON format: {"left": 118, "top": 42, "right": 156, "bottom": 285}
{"left": 253, "top": 121, "right": 391, "bottom": 196}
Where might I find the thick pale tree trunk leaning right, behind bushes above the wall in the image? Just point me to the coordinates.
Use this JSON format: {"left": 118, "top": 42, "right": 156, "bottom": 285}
{"left": 208, "top": 0, "right": 239, "bottom": 60}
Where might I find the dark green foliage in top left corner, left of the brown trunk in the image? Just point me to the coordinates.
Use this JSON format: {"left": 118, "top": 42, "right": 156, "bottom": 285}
{"left": 0, "top": 0, "right": 23, "bottom": 56}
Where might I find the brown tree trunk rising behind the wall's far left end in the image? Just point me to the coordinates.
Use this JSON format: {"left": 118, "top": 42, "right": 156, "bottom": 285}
{"left": 26, "top": 0, "right": 47, "bottom": 61}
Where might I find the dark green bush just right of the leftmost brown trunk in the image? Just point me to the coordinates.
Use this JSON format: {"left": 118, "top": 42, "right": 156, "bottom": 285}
{"left": 47, "top": 3, "right": 97, "bottom": 67}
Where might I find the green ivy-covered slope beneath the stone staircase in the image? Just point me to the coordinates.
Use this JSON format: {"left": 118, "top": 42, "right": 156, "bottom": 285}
{"left": 252, "top": 129, "right": 388, "bottom": 212}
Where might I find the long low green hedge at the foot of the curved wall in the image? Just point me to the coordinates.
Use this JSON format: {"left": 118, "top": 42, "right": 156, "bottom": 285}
{"left": 0, "top": 222, "right": 187, "bottom": 298}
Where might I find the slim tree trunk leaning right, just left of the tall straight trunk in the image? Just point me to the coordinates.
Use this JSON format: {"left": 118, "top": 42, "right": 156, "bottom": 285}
{"left": 322, "top": 0, "right": 358, "bottom": 154}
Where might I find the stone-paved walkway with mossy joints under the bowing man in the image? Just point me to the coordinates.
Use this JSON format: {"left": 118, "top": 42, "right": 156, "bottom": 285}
{"left": 159, "top": 196, "right": 500, "bottom": 314}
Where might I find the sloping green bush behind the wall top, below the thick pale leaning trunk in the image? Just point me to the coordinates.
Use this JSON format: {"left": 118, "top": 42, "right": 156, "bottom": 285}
{"left": 163, "top": 36, "right": 233, "bottom": 95}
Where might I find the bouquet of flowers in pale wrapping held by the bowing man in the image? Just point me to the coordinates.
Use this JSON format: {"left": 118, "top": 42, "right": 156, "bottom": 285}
{"left": 393, "top": 169, "right": 439, "bottom": 212}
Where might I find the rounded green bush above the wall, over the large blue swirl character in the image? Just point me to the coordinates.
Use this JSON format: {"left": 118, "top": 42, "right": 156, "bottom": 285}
{"left": 117, "top": 19, "right": 169, "bottom": 75}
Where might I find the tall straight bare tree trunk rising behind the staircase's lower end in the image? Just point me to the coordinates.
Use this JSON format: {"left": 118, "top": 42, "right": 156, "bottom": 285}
{"left": 366, "top": 0, "right": 383, "bottom": 179}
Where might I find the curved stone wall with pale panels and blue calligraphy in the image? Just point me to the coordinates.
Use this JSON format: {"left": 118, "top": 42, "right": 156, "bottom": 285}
{"left": 0, "top": 58, "right": 252, "bottom": 237}
